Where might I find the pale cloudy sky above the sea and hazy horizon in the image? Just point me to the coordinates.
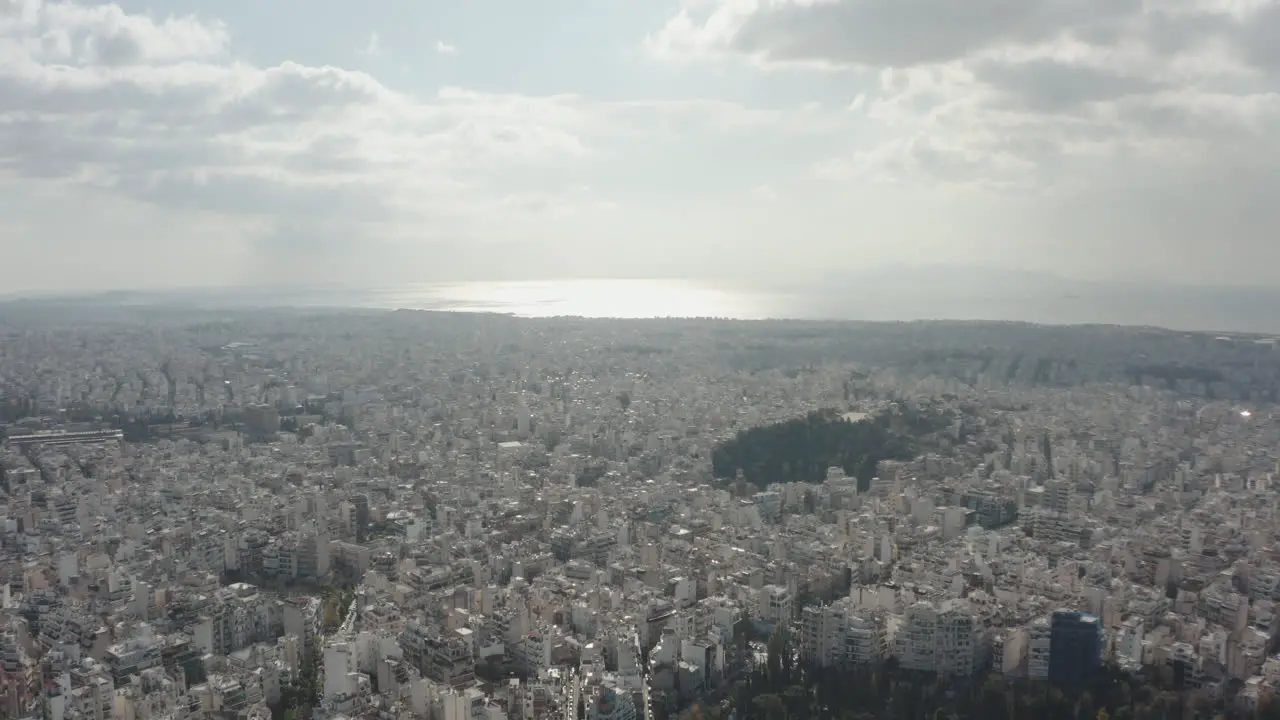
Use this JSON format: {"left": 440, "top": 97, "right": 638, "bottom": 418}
{"left": 0, "top": 0, "right": 1280, "bottom": 292}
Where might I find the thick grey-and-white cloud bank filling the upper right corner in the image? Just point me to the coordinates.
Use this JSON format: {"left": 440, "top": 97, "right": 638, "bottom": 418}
{"left": 645, "top": 0, "right": 1280, "bottom": 191}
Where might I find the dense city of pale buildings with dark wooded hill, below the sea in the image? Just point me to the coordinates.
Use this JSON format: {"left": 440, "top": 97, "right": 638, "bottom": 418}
{"left": 0, "top": 304, "right": 1280, "bottom": 720}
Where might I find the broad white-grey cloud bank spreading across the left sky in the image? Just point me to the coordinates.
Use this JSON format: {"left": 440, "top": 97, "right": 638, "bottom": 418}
{"left": 0, "top": 0, "right": 829, "bottom": 292}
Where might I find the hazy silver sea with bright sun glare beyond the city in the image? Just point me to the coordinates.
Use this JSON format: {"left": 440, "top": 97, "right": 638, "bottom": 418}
{"left": 10, "top": 273, "right": 1280, "bottom": 334}
